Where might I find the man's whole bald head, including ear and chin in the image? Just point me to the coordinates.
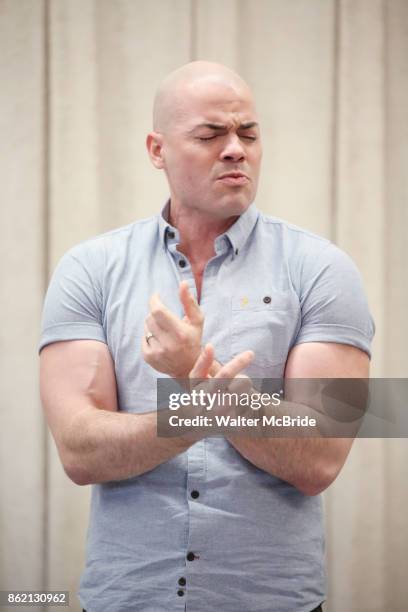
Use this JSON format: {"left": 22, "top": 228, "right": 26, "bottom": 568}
{"left": 146, "top": 61, "right": 262, "bottom": 223}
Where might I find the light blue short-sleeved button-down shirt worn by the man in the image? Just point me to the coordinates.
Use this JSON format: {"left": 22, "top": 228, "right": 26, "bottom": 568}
{"left": 40, "top": 205, "right": 374, "bottom": 612}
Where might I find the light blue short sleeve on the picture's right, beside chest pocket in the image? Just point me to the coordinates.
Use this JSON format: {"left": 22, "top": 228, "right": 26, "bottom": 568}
{"left": 294, "top": 243, "right": 375, "bottom": 357}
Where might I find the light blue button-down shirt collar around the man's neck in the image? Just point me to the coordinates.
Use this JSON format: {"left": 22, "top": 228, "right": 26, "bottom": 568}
{"left": 159, "top": 200, "right": 259, "bottom": 255}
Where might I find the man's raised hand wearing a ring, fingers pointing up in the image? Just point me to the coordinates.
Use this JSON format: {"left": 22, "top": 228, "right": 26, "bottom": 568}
{"left": 142, "top": 281, "right": 204, "bottom": 378}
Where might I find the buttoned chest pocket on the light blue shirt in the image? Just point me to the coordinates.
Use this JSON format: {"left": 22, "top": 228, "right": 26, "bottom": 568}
{"left": 231, "top": 291, "right": 300, "bottom": 370}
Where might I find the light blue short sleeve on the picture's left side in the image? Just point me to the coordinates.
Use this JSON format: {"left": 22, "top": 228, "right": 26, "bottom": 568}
{"left": 39, "top": 243, "right": 106, "bottom": 351}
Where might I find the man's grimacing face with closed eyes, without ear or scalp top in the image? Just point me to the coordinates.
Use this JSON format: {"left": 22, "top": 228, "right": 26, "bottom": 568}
{"left": 158, "top": 81, "right": 262, "bottom": 219}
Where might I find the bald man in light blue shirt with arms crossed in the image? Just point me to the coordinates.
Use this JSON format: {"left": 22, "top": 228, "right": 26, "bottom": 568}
{"left": 41, "top": 62, "right": 373, "bottom": 612}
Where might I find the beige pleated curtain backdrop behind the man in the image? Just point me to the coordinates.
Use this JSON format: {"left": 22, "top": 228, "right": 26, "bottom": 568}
{"left": 0, "top": 0, "right": 408, "bottom": 612}
